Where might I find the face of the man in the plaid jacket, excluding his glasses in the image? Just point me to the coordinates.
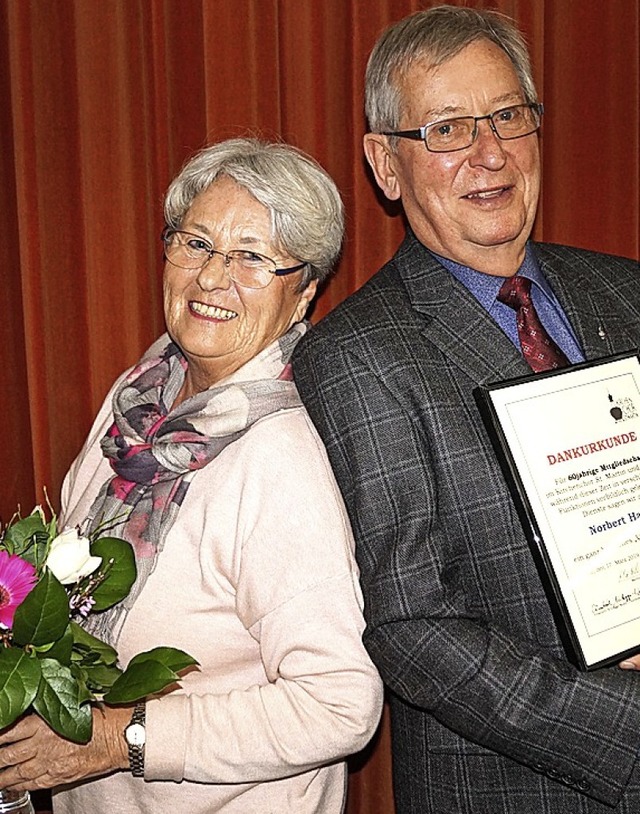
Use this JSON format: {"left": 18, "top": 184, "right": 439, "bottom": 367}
{"left": 365, "top": 40, "right": 540, "bottom": 275}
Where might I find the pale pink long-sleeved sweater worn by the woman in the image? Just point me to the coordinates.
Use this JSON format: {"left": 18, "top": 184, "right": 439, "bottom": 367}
{"left": 53, "top": 388, "right": 382, "bottom": 814}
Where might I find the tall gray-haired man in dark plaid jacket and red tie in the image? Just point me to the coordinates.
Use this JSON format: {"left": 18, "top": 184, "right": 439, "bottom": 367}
{"left": 294, "top": 6, "right": 640, "bottom": 814}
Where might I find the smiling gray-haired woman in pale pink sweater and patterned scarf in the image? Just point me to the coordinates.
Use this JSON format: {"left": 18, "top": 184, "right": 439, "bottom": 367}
{"left": 1, "top": 139, "right": 381, "bottom": 814}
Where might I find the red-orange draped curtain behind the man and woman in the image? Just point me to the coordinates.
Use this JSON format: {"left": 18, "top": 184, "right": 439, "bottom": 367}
{"left": 0, "top": 0, "right": 640, "bottom": 814}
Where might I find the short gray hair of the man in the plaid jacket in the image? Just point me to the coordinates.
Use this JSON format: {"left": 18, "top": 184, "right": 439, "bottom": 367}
{"left": 365, "top": 6, "right": 538, "bottom": 133}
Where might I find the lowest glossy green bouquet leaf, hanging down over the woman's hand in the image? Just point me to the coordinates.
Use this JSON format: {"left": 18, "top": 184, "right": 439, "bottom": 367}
{"left": 33, "top": 659, "right": 93, "bottom": 743}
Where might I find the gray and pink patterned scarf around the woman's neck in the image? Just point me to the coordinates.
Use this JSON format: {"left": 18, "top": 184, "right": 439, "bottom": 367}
{"left": 84, "top": 322, "right": 308, "bottom": 644}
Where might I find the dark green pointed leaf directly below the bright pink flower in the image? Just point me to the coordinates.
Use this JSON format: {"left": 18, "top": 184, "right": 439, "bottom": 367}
{"left": 13, "top": 571, "right": 69, "bottom": 646}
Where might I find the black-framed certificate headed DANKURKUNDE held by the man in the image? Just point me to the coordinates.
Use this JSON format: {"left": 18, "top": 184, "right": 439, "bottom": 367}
{"left": 474, "top": 353, "right": 640, "bottom": 670}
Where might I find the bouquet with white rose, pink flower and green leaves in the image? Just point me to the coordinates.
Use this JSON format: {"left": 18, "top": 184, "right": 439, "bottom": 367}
{"left": 0, "top": 506, "right": 196, "bottom": 743}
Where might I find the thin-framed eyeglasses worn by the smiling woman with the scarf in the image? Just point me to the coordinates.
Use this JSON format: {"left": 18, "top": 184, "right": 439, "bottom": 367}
{"left": 162, "top": 226, "right": 307, "bottom": 288}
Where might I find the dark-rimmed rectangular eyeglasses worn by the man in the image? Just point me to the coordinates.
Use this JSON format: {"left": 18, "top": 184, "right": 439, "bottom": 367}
{"left": 381, "top": 104, "right": 543, "bottom": 153}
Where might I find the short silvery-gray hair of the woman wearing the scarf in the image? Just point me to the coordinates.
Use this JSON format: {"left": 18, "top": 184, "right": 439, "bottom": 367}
{"left": 164, "top": 138, "right": 344, "bottom": 290}
